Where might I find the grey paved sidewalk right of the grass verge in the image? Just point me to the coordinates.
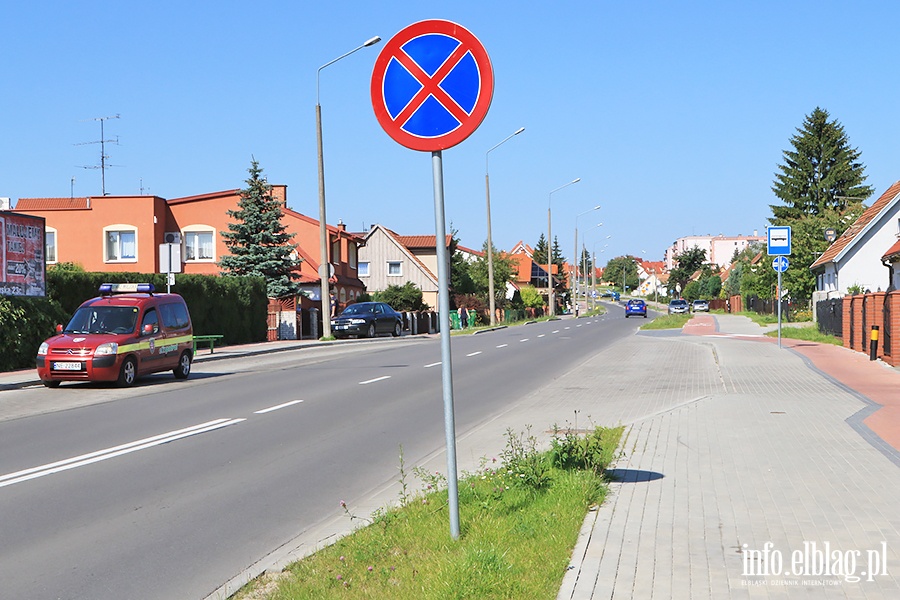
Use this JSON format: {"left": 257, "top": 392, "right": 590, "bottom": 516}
{"left": 559, "top": 315, "right": 900, "bottom": 600}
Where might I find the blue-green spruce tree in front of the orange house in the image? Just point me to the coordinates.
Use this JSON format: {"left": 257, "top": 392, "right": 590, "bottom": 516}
{"left": 219, "top": 159, "right": 300, "bottom": 298}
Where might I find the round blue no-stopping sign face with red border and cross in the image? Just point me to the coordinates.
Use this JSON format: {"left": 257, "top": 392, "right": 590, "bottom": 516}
{"left": 371, "top": 19, "right": 494, "bottom": 152}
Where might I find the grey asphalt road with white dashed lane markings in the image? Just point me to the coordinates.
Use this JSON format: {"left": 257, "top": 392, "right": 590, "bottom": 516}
{"left": 0, "top": 307, "right": 643, "bottom": 600}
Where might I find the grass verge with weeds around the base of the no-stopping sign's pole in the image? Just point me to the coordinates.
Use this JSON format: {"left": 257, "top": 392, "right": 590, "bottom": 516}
{"left": 235, "top": 427, "right": 624, "bottom": 600}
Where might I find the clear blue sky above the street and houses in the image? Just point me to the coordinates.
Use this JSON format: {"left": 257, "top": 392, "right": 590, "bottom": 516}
{"left": 0, "top": 0, "right": 900, "bottom": 264}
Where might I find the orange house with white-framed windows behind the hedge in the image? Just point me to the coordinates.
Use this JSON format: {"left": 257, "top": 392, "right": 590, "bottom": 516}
{"left": 16, "top": 185, "right": 365, "bottom": 308}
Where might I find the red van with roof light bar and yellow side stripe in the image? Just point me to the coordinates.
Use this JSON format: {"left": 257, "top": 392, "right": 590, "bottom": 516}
{"left": 36, "top": 283, "right": 194, "bottom": 387}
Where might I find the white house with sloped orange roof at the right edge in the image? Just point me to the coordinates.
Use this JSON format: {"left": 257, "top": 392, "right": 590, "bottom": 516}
{"left": 810, "top": 181, "right": 900, "bottom": 302}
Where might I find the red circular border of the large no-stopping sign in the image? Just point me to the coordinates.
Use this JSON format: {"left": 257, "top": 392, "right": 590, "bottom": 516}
{"left": 371, "top": 19, "right": 494, "bottom": 152}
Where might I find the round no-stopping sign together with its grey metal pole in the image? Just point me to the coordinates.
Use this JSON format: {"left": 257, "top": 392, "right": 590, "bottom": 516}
{"left": 370, "top": 20, "right": 494, "bottom": 539}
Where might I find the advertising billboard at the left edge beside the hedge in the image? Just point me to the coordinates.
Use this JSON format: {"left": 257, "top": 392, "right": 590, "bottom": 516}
{"left": 0, "top": 211, "right": 47, "bottom": 296}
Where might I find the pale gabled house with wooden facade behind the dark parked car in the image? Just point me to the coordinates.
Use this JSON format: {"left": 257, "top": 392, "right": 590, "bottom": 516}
{"left": 358, "top": 224, "right": 452, "bottom": 308}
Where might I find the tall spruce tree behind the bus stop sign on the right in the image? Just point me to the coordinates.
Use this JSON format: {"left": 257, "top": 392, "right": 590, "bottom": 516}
{"left": 769, "top": 107, "right": 873, "bottom": 225}
